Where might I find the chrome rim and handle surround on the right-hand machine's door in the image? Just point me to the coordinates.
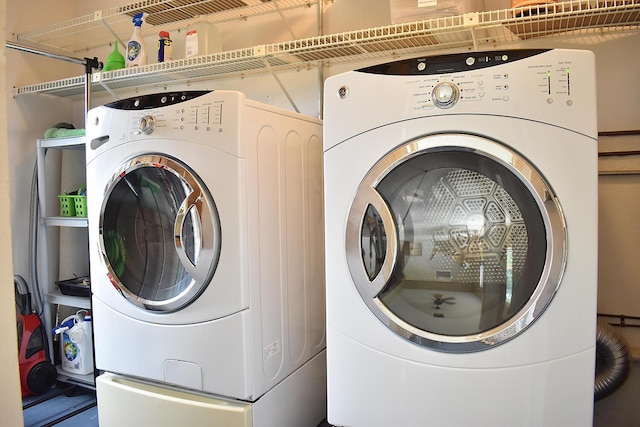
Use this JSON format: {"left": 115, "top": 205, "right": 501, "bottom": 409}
{"left": 345, "top": 134, "right": 567, "bottom": 352}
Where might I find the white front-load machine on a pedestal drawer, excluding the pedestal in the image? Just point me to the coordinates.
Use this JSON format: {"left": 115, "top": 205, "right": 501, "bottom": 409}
{"left": 87, "top": 91, "right": 325, "bottom": 419}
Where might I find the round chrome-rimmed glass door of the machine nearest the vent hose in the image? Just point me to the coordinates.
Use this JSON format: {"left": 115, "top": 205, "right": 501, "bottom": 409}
{"left": 345, "top": 134, "right": 566, "bottom": 352}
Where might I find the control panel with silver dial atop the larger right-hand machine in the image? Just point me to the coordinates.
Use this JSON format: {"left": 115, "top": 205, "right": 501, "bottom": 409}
{"left": 325, "top": 49, "right": 597, "bottom": 140}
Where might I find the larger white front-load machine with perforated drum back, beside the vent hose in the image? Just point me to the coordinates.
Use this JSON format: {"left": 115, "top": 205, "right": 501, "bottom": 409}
{"left": 324, "top": 50, "right": 598, "bottom": 426}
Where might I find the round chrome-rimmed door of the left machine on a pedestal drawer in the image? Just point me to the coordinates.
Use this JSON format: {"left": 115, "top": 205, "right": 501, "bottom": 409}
{"left": 99, "top": 154, "right": 220, "bottom": 312}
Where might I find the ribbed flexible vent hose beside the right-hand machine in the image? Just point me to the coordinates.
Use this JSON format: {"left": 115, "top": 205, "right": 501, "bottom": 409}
{"left": 594, "top": 322, "right": 631, "bottom": 400}
